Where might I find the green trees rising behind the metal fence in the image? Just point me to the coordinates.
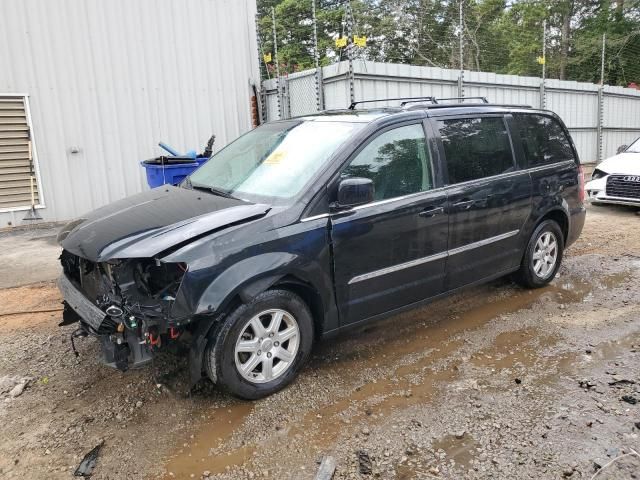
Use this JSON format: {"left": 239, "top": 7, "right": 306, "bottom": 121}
{"left": 258, "top": 0, "right": 640, "bottom": 85}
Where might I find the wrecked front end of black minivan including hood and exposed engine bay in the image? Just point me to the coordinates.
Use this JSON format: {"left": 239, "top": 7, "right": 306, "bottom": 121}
{"left": 57, "top": 185, "right": 269, "bottom": 376}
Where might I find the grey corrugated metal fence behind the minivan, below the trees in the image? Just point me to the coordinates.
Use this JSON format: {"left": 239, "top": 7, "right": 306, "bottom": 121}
{"left": 264, "top": 60, "right": 640, "bottom": 162}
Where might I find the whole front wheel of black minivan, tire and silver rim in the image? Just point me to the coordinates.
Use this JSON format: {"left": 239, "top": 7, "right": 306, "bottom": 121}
{"left": 204, "top": 290, "right": 314, "bottom": 400}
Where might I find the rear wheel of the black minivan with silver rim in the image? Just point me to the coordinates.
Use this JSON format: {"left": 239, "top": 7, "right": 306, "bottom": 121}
{"left": 515, "top": 220, "right": 564, "bottom": 288}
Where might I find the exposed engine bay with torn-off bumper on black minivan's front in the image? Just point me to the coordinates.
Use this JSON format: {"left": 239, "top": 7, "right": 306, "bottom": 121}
{"left": 60, "top": 250, "right": 187, "bottom": 371}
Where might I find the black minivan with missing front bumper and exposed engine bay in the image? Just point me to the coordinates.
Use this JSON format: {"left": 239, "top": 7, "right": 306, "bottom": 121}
{"left": 59, "top": 99, "right": 585, "bottom": 399}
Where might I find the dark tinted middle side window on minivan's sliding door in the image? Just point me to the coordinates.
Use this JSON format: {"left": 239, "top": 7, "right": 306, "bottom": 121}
{"left": 438, "top": 117, "right": 514, "bottom": 183}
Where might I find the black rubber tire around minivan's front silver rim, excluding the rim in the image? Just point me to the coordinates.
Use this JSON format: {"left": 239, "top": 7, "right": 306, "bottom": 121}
{"left": 203, "top": 289, "right": 314, "bottom": 400}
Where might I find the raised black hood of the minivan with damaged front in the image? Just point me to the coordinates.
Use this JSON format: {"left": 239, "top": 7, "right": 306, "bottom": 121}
{"left": 58, "top": 185, "right": 270, "bottom": 262}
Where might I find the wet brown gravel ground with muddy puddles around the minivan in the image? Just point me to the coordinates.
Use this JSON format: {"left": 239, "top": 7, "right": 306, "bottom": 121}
{"left": 0, "top": 203, "right": 640, "bottom": 479}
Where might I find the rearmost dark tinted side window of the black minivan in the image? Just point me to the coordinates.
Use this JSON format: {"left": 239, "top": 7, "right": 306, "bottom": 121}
{"left": 514, "top": 113, "right": 575, "bottom": 167}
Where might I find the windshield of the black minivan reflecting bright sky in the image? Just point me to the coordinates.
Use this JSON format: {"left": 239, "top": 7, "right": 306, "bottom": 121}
{"left": 186, "top": 120, "right": 363, "bottom": 203}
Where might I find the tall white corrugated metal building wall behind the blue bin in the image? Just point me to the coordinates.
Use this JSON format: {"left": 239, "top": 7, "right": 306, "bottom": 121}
{"left": 0, "top": 0, "right": 259, "bottom": 227}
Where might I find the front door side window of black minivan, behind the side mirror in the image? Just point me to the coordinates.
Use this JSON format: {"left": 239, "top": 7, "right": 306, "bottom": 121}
{"left": 341, "top": 124, "right": 433, "bottom": 200}
